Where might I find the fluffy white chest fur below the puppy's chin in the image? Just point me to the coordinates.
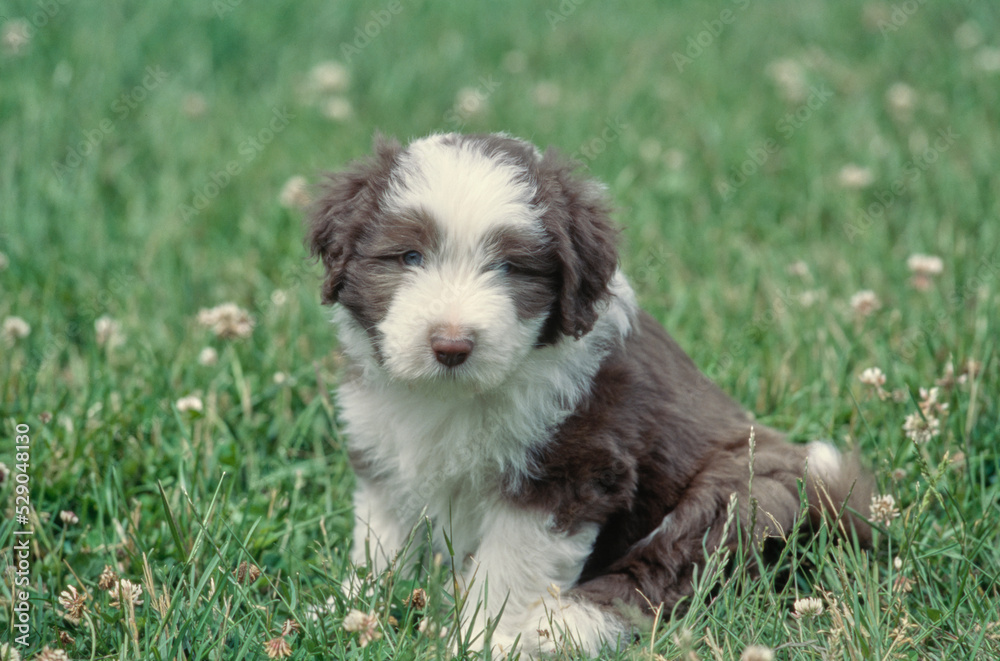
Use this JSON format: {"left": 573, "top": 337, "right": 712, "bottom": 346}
{"left": 338, "top": 372, "right": 569, "bottom": 559}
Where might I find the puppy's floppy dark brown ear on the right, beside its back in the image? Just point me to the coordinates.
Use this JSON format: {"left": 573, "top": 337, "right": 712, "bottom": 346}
{"left": 535, "top": 149, "right": 618, "bottom": 343}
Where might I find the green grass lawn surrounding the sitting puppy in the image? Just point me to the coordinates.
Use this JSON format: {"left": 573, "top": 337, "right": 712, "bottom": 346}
{"left": 0, "top": 0, "right": 1000, "bottom": 660}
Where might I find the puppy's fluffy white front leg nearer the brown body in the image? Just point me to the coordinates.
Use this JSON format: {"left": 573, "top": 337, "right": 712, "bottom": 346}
{"left": 465, "top": 503, "right": 622, "bottom": 657}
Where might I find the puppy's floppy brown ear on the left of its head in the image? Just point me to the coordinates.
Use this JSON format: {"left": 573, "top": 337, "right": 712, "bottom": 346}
{"left": 306, "top": 134, "right": 403, "bottom": 305}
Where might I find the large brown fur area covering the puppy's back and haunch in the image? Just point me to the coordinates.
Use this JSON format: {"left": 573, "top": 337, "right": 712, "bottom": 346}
{"left": 508, "top": 313, "right": 870, "bottom": 612}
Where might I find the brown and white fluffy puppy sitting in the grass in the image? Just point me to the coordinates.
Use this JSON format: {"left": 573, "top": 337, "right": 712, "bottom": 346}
{"left": 308, "top": 134, "right": 869, "bottom": 655}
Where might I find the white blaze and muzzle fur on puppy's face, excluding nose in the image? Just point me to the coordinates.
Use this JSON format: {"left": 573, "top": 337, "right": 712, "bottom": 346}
{"left": 378, "top": 136, "right": 544, "bottom": 390}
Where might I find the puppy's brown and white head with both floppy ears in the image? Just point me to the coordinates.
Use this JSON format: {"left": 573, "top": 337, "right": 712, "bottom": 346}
{"left": 308, "top": 134, "right": 617, "bottom": 390}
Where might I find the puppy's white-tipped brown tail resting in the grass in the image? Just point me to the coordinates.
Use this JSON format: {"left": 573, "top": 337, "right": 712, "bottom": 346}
{"left": 806, "top": 441, "right": 874, "bottom": 547}
